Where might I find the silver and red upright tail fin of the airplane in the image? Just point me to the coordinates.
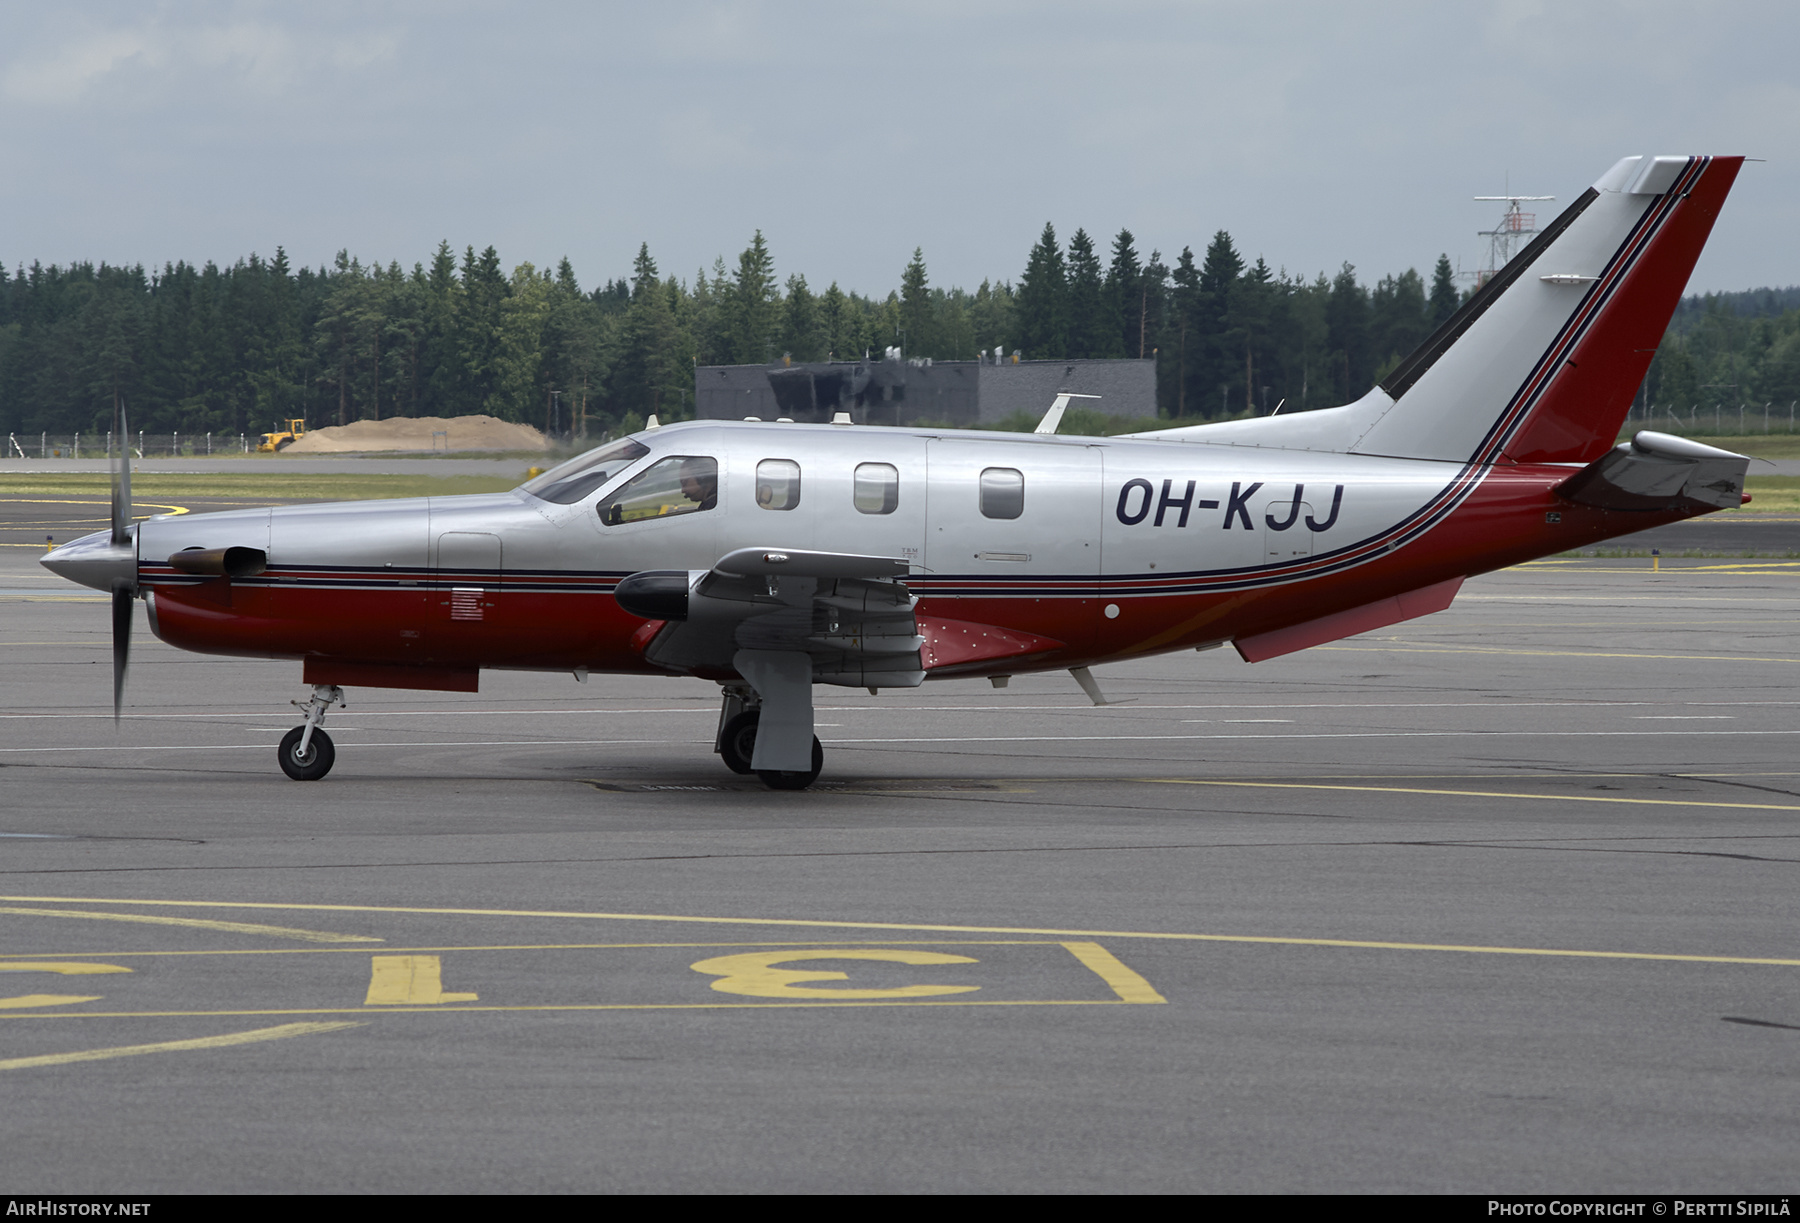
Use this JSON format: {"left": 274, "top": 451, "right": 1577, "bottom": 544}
{"left": 1136, "top": 157, "right": 1744, "bottom": 463}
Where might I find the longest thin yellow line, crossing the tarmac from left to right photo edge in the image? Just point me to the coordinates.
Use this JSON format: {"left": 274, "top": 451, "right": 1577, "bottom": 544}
{"left": 0, "top": 895, "right": 1800, "bottom": 972}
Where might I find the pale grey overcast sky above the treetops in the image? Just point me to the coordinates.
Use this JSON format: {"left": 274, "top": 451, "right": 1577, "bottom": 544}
{"left": 0, "top": 0, "right": 1800, "bottom": 294}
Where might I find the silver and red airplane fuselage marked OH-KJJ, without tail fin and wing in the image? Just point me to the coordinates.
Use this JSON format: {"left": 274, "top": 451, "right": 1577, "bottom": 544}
{"left": 91, "top": 421, "right": 1690, "bottom": 690}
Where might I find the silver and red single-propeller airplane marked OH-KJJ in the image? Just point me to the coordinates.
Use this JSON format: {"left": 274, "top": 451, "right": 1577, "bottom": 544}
{"left": 43, "top": 157, "right": 1748, "bottom": 789}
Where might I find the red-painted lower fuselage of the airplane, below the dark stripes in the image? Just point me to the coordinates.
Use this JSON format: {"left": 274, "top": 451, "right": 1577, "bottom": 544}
{"left": 155, "top": 465, "right": 1713, "bottom": 674}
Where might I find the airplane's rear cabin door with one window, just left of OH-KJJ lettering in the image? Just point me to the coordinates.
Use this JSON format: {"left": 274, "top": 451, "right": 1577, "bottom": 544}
{"left": 925, "top": 438, "right": 1102, "bottom": 650}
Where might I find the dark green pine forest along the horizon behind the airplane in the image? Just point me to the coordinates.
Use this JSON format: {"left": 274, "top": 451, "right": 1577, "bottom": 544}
{"left": 0, "top": 225, "right": 1800, "bottom": 444}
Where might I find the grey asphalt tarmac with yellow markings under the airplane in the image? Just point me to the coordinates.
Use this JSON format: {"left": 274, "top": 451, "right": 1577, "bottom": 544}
{"left": 0, "top": 511, "right": 1800, "bottom": 1194}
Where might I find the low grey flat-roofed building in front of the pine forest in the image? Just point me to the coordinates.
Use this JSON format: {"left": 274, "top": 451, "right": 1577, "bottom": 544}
{"left": 693, "top": 358, "right": 1156, "bottom": 429}
